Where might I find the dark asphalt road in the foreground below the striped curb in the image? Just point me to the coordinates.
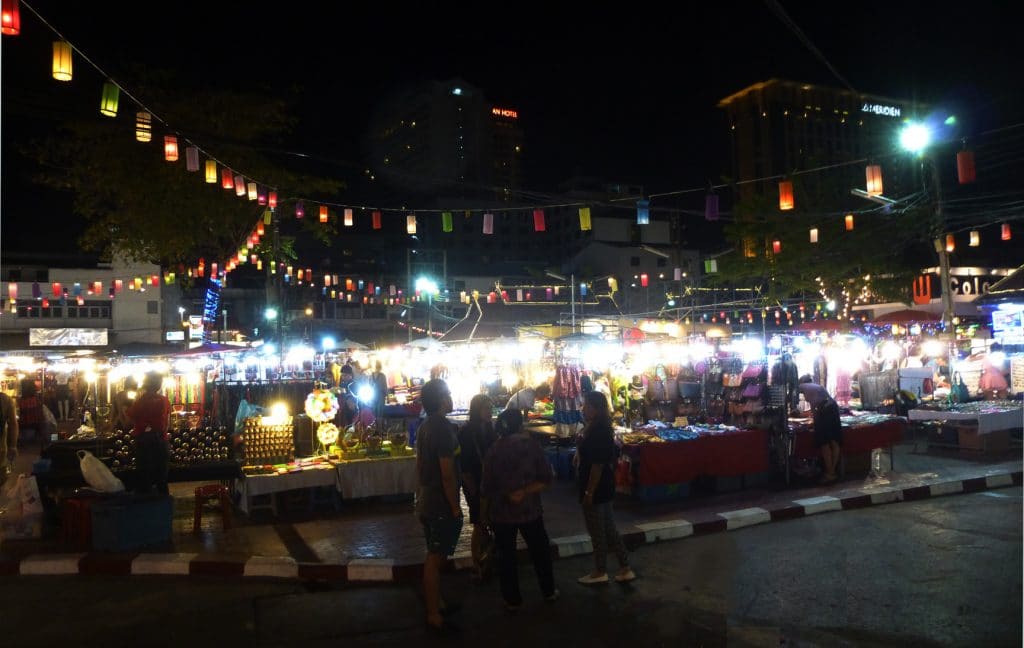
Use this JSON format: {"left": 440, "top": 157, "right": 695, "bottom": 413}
{"left": 0, "top": 487, "right": 1022, "bottom": 647}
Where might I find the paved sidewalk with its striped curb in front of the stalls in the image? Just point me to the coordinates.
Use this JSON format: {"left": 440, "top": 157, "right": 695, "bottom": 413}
{"left": 0, "top": 443, "right": 1022, "bottom": 581}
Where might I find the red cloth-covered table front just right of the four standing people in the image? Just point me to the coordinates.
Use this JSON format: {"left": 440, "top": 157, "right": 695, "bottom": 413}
{"left": 624, "top": 428, "right": 769, "bottom": 486}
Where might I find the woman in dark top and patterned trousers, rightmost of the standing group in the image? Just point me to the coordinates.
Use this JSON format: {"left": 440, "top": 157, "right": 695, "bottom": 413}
{"left": 577, "top": 391, "right": 637, "bottom": 585}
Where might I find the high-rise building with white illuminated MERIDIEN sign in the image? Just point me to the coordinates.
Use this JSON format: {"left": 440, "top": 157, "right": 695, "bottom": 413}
{"left": 718, "top": 79, "right": 925, "bottom": 199}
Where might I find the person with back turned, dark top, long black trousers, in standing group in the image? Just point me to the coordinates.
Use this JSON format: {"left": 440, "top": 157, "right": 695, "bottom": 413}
{"left": 480, "top": 409, "right": 558, "bottom": 612}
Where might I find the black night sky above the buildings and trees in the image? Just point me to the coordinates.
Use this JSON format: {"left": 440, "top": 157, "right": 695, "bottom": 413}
{"left": 2, "top": 0, "right": 1024, "bottom": 250}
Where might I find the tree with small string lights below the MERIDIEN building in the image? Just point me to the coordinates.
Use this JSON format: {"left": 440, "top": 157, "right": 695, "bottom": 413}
{"left": 707, "top": 174, "right": 930, "bottom": 312}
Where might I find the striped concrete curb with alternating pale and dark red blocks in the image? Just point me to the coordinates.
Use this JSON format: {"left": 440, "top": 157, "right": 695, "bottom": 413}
{"left": 0, "top": 471, "right": 1024, "bottom": 582}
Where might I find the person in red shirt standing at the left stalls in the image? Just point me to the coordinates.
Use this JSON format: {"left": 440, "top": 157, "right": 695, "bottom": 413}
{"left": 128, "top": 372, "right": 171, "bottom": 495}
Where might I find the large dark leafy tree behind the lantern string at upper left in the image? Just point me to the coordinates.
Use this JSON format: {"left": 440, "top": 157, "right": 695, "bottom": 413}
{"left": 26, "top": 75, "right": 344, "bottom": 267}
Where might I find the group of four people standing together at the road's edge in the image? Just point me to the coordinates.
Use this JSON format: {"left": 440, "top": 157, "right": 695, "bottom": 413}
{"left": 416, "top": 379, "right": 637, "bottom": 635}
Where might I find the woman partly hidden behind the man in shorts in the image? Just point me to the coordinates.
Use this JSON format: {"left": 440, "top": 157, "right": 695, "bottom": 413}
{"left": 459, "top": 394, "right": 498, "bottom": 582}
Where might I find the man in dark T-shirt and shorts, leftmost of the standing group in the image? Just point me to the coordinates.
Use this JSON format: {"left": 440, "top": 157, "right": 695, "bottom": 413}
{"left": 416, "top": 380, "right": 463, "bottom": 635}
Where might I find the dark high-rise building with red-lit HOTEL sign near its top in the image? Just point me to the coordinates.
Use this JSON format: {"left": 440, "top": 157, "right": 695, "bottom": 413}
{"left": 367, "top": 79, "right": 523, "bottom": 201}
